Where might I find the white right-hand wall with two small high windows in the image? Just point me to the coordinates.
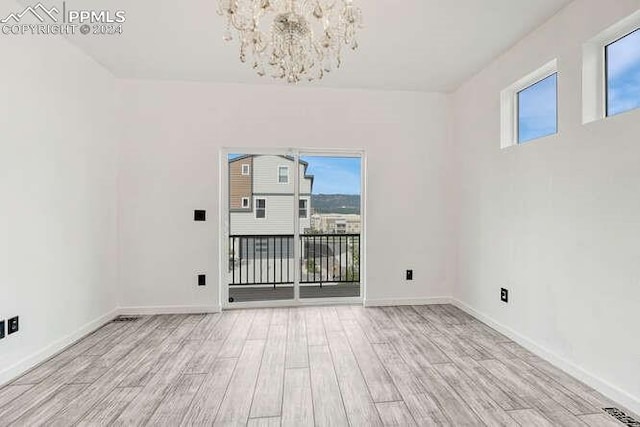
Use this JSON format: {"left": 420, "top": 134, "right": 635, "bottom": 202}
{"left": 454, "top": 0, "right": 640, "bottom": 410}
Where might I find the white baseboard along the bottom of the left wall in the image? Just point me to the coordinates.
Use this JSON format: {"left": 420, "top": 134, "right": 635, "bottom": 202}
{"left": 0, "top": 309, "right": 119, "bottom": 387}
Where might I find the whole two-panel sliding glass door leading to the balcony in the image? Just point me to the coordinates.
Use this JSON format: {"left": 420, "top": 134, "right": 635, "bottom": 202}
{"left": 223, "top": 151, "right": 363, "bottom": 306}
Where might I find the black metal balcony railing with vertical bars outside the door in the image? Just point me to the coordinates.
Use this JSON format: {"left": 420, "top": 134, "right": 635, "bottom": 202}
{"left": 229, "top": 234, "right": 361, "bottom": 287}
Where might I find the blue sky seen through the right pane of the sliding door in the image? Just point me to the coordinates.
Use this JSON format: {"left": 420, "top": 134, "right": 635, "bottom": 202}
{"left": 301, "top": 156, "right": 361, "bottom": 194}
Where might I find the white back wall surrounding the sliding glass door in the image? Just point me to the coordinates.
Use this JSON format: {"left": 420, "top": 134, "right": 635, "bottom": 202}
{"left": 119, "top": 81, "right": 453, "bottom": 308}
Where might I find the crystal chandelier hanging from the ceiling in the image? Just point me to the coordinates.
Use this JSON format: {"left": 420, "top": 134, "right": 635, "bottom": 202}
{"left": 218, "top": 0, "right": 362, "bottom": 83}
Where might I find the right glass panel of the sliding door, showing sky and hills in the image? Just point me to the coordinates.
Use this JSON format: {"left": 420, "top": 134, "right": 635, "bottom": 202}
{"left": 300, "top": 155, "right": 362, "bottom": 299}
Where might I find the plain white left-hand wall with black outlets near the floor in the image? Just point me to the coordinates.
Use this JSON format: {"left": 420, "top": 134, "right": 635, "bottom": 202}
{"left": 0, "top": 9, "right": 117, "bottom": 384}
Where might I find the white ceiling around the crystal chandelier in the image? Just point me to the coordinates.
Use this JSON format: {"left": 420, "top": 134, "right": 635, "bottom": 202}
{"left": 30, "top": 0, "right": 571, "bottom": 92}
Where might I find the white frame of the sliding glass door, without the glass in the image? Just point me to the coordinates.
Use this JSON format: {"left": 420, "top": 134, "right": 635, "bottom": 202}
{"left": 218, "top": 147, "right": 367, "bottom": 310}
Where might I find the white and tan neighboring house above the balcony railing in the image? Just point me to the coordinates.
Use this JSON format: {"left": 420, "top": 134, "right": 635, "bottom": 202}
{"left": 229, "top": 155, "right": 313, "bottom": 236}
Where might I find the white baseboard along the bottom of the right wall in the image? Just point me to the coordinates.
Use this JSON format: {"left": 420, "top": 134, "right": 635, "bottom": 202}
{"left": 450, "top": 298, "right": 640, "bottom": 413}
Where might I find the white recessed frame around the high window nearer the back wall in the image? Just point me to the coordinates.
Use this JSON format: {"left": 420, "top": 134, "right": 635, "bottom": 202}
{"left": 500, "top": 58, "right": 561, "bottom": 149}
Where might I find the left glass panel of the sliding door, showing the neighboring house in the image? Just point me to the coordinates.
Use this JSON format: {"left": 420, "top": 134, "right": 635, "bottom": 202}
{"left": 227, "top": 154, "right": 297, "bottom": 303}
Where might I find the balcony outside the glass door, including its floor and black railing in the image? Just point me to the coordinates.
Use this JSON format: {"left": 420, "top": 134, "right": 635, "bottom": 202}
{"left": 229, "top": 234, "right": 361, "bottom": 302}
